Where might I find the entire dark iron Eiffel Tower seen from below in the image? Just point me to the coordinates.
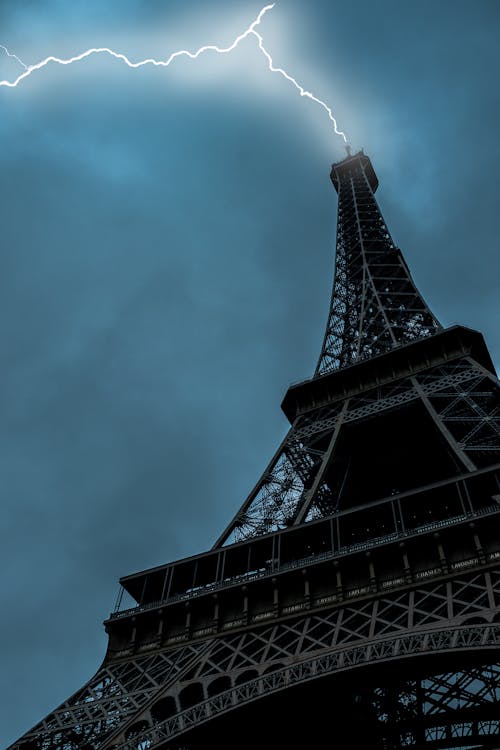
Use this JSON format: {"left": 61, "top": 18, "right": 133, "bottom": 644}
{"left": 12, "top": 151, "right": 500, "bottom": 750}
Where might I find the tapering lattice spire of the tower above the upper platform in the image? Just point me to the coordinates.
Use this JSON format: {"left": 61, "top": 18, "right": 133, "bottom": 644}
{"left": 315, "top": 155, "right": 441, "bottom": 375}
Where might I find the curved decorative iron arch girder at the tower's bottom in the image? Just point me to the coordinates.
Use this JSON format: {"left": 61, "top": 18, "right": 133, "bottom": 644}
{"left": 115, "top": 625, "right": 500, "bottom": 750}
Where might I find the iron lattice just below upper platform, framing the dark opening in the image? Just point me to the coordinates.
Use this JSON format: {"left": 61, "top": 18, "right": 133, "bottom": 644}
{"left": 223, "top": 358, "right": 500, "bottom": 543}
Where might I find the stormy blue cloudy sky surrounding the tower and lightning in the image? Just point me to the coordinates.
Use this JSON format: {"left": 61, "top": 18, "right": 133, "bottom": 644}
{"left": 0, "top": 0, "right": 500, "bottom": 744}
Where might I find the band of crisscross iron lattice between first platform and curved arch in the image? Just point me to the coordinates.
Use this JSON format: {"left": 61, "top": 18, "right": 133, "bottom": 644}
{"left": 183, "top": 571, "right": 500, "bottom": 684}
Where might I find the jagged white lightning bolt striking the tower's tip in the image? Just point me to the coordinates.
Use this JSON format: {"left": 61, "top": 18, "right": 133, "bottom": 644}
{"left": 0, "top": 3, "right": 347, "bottom": 143}
